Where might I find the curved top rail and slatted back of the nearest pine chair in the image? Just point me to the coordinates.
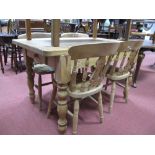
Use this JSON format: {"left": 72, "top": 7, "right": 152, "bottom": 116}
{"left": 68, "top": 43, "right": 119, "bottom": 92}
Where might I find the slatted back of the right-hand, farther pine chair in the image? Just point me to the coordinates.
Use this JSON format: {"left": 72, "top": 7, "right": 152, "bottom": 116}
{"left": 109, "top": 40, "right": 143, "bottom": 75}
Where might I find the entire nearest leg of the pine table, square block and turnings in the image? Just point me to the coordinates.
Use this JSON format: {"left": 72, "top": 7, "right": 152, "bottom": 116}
{"left": 56, "top": 56, "right": 71, "bottom": 133}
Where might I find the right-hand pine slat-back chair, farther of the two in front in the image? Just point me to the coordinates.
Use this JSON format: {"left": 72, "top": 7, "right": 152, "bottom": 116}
{"left": 105, "top": 41, "right": 143, "bottom": 112}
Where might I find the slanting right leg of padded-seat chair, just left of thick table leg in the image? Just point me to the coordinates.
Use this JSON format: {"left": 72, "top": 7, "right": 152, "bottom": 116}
{"left": 47, "top": 80, "right": 57, "bottom": 118}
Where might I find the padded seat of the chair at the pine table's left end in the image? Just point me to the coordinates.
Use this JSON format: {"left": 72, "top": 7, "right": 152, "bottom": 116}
{"left": 33, "top": 64, "right": 55, "bottom": 74}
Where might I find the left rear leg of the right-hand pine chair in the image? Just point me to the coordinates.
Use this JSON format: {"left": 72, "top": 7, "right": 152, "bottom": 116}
{"left": 109, "top": 81, "right": 116, "bottom": 112}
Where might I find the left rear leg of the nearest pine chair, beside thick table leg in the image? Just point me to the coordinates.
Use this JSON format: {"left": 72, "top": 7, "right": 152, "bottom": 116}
{"left": 72, "top": 99, "right": 79, "bottom": 134}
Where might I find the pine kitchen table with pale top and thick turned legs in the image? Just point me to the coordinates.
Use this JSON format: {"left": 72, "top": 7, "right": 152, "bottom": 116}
{"left": 13, "top": 38, "right": 119, "bottom": 132}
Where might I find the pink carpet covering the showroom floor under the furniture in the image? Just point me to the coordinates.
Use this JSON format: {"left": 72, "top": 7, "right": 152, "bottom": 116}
{"left": 0, "top": 52, "right": 155, "bottom": 135}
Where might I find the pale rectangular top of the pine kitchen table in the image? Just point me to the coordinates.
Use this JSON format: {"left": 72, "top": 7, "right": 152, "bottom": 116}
{"left": 13, "top": 38, "right": 120, "bottom": 57}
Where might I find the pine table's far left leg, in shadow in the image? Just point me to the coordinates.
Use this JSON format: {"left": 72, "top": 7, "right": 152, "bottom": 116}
{"left": 24, "top": 51, "right": 35, "bottom": 103}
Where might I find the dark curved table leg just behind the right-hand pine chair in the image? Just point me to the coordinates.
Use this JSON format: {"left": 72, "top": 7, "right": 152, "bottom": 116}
{"left": 133, "top": 49, "right": 145, "bottom": 88}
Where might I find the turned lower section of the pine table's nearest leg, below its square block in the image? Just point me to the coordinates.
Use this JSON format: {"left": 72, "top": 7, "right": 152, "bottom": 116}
{"left": 57, "top": 83, "right": 68, "bottom": 133}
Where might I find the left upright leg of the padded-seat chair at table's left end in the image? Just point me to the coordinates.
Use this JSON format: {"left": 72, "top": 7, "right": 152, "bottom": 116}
{"left": 38, "top": 74, "right": 42, "bottom": 110}
